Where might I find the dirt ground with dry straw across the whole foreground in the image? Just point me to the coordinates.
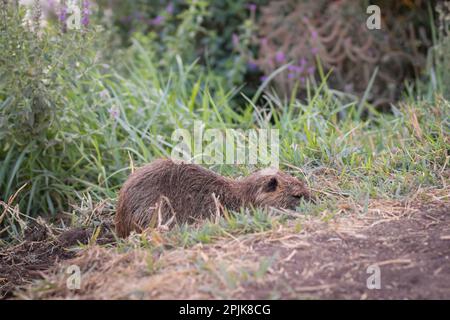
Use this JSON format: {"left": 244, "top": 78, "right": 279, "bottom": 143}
{"left": 0, "top": 189, "right": 450, "bottom": 299}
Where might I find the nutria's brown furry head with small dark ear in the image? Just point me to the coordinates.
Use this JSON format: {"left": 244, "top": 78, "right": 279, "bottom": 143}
{"left": 243, "top": 168, "right": 313, "bottom": 210}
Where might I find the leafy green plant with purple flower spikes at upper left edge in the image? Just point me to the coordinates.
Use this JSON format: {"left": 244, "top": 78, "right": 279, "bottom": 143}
{"left": 0, "top": 0, "right": 101, "bottom": 146}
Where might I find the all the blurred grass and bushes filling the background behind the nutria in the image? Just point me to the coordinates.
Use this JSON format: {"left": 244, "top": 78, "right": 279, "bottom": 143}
{"left": 0, "top": 0, "right": 450, "bottom": 236}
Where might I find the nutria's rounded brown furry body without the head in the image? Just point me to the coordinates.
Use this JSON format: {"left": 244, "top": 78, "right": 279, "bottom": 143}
{"left": 116, "top": 159, "right": 236, "bottom": 237}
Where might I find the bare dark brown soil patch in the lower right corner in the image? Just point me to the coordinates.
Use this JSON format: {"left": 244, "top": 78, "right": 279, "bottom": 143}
{"left": 241, "top": 205, "right": 450, "bottom": 299}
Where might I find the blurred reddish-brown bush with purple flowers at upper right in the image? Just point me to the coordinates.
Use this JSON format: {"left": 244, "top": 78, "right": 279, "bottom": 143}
{"left": 248, "top": 0, "right": 429, "bottom": 106}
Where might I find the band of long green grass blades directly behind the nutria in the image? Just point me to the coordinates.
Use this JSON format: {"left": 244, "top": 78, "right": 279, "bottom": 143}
{"left": 0, "top": 32, "right": 450, "bottom": 243}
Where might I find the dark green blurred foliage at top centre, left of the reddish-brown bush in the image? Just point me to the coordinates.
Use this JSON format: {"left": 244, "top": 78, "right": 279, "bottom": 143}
{"left": 96, "top": 0, "right": 267, "bottom": 88}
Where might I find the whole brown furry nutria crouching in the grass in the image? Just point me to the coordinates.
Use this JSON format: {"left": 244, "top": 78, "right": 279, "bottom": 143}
{"left": 115, "top": 159, "right": 310, "bottom": 237}
